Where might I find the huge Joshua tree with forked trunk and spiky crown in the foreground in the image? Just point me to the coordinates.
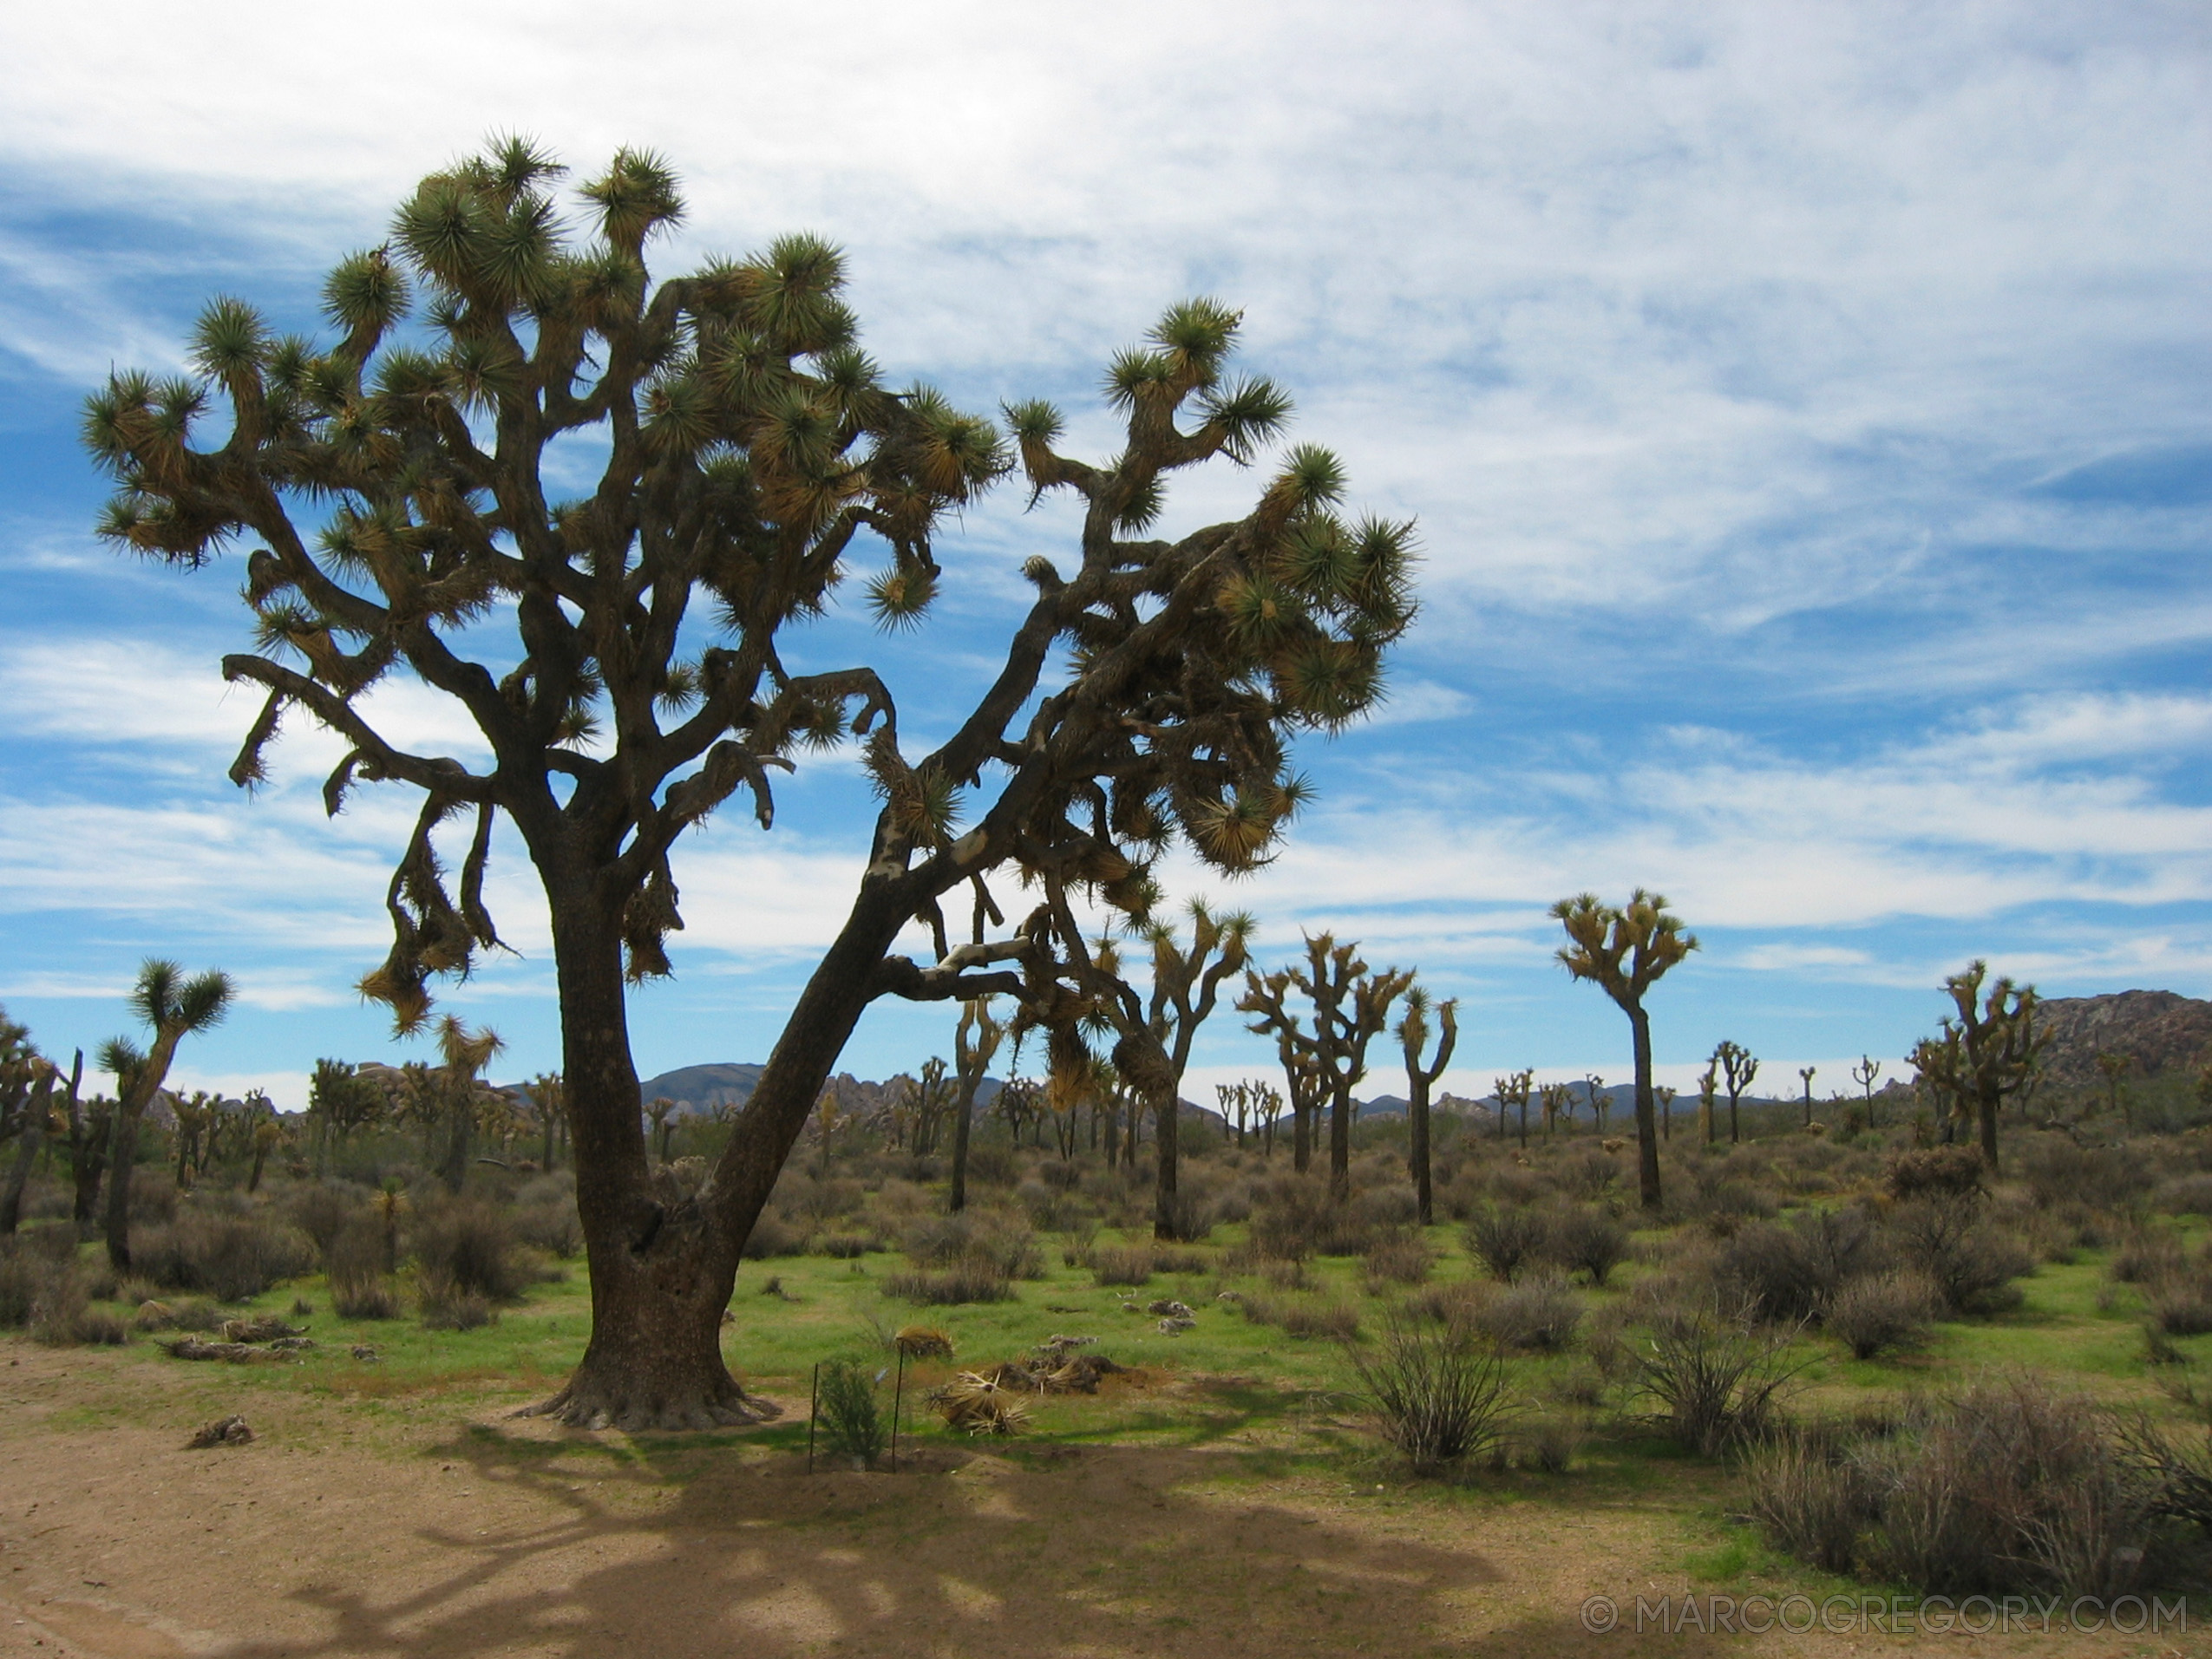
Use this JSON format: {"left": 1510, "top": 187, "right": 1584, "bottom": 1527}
{"left": 86, "top": 141, "right": 1413, "bottom": 1427}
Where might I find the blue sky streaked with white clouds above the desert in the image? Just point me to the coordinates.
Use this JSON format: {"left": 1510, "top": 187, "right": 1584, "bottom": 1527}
{"left": 0, "top": 0, "right": 2212, "bottom": 1104}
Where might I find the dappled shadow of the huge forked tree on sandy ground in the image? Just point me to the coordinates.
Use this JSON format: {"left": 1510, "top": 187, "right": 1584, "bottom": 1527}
{"left": 203, "top": 1434, "right": 1725, "bottom": 1659}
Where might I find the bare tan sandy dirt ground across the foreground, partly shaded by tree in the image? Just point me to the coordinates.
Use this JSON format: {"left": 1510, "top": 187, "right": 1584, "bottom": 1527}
{"left": 0, "top": 1345, "right": 2185, "bottom": 1659}
